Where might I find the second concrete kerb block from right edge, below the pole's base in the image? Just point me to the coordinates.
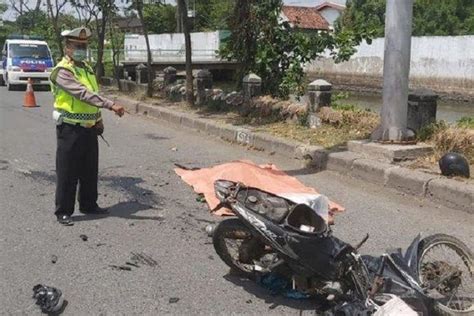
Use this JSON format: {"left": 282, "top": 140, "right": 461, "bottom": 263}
{"left": 385, "top": 168, "right": 437, "bottom": 196}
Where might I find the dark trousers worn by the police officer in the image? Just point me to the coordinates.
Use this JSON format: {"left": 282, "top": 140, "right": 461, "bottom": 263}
{"left": 55, "top": 123, "right": 99, "bottom": 216}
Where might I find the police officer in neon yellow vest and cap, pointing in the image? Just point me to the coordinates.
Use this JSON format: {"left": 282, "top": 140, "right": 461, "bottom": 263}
{"left": 51, "top": 27, "right": 125, "bottom": 226}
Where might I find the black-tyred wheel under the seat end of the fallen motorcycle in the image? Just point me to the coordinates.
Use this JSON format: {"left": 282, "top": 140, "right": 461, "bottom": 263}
{"left": 212, "top": 218, "right": 265, "bottom": 279}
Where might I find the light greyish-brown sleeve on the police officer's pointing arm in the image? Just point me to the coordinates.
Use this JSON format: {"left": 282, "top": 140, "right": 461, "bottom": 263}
{"left": 55, "top": 69, "right": 114, "bottom": 109}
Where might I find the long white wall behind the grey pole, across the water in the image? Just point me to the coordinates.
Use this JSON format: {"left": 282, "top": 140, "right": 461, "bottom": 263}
{"left": 306, "top": 36, "right": 474, "bottom": 94}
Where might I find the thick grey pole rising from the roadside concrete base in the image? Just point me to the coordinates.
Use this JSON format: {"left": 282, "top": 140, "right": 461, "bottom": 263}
{"left": 371, "top": 0, "right": 414, "bottom": 142}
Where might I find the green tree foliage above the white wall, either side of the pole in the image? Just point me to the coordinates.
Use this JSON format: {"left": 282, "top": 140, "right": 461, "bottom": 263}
{"left": 336, "top": 0, "right": 474, "bottom": 37}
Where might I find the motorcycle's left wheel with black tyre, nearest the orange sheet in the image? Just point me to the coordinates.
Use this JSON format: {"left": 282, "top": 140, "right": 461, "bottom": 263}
{"left": 212, "top": 218, "right": 264, "bottom": 279}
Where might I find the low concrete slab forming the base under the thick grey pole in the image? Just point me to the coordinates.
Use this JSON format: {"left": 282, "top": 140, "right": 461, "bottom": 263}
{"left": 347, "top": 140, "right": 433, "bottom": 162}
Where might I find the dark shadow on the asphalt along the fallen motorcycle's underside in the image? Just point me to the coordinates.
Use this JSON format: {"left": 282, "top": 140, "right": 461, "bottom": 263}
{"left": 224, "top": 273, "right": 319, "bottom": 312}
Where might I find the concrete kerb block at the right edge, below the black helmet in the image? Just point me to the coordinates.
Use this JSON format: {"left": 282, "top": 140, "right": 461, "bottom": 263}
{"left": 426, "top": 178, "right": 474, "bottom": 214}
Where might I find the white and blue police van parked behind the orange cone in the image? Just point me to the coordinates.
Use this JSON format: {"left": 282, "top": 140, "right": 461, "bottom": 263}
{"left": 0, "top": 35, "right": 54, "bottom": 90}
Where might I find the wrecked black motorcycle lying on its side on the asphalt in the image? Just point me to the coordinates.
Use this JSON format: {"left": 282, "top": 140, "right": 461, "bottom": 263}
{"left": 213, "top": 180, "right": 474, "bottom": 315}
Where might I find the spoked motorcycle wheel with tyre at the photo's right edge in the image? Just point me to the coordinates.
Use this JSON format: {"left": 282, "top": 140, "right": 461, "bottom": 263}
{"left": 418, "top": 234, "right": 474, "bottom": 316}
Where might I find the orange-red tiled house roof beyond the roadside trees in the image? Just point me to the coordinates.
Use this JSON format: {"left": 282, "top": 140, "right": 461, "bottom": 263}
{"left": 283, "top": 6, "right": 329, "bottom": 30}
